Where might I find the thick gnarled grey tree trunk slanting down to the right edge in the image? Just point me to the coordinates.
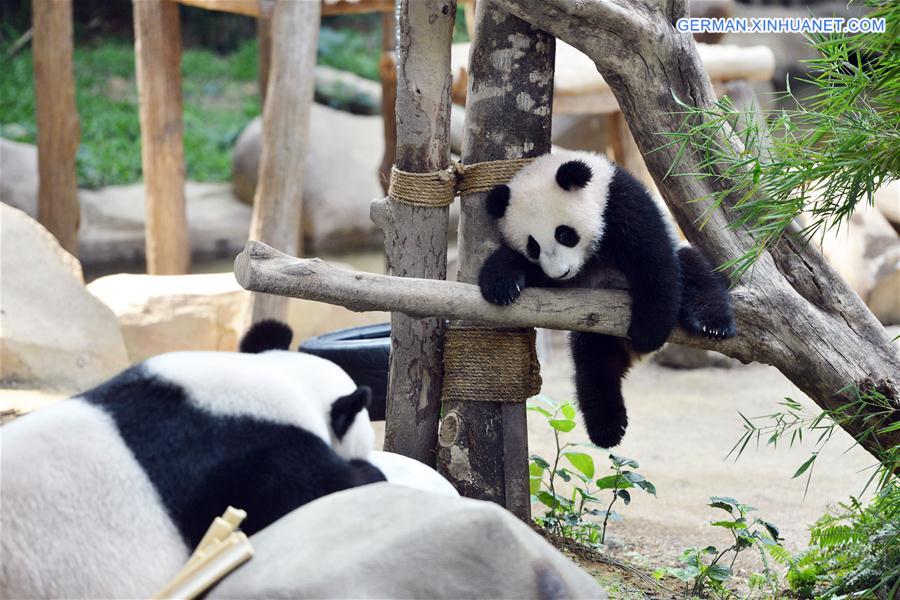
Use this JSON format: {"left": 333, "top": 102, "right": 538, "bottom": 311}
{"left": 486, "top": 0, "right": 900, "bottom": 455}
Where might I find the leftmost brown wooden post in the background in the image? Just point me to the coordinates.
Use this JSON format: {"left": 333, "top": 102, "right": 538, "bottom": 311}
{"left": 32, "top": 0, "right": 81, "bottom": 255}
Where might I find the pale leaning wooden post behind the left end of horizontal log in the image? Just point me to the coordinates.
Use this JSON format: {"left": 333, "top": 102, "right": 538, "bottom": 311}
{"left": 243, "top": 2, "right": 320, "bottom": 322}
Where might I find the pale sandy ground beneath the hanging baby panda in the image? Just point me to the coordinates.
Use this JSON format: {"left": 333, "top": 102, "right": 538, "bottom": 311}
{"left": 512, "top": 334, "right": 874, "bottom": 574}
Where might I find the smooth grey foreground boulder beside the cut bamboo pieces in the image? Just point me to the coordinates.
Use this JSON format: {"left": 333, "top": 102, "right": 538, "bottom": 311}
{"left": 207, "top": 483, "right": 607, "bottom": 599}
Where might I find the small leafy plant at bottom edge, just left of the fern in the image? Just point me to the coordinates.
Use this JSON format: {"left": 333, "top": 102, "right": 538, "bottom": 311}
{"left": 654, "top": 496, "right": 789, "bottom": 598}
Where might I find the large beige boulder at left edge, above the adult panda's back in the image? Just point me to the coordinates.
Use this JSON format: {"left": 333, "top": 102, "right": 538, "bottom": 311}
{"left": 0, "top": 204, "right": 128, "bottom": 390}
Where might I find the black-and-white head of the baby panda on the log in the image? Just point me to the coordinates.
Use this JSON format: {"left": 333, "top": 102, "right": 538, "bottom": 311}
{"left": 487, "top": 152, "right": 614, "bottom": 280}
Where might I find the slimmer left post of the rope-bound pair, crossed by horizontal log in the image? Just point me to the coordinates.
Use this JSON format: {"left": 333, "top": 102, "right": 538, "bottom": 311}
{"left": 372, "top": 0, "right": 456, "bottom": 465}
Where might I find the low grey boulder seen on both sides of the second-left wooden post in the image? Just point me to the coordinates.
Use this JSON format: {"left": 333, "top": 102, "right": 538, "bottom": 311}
{"left": 78, "top": 182, "right": 251, "bottom": 272}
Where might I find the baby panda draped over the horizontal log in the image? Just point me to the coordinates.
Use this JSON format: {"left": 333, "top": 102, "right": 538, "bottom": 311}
{"left": 478, "top": 152, "right": 735, "bottom": 448}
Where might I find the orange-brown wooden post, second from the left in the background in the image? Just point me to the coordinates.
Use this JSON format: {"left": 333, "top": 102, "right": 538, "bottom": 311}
{"left": 133, "top": 0, "right": 190, "bottom": 275}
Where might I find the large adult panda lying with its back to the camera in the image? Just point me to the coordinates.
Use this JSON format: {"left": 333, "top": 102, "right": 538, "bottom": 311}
{"left": 0, "top": 323, "right": 385, "bottom": 598}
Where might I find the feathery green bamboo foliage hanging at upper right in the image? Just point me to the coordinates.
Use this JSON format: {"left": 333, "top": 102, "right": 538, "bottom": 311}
{"left": 666, "top": 0, "right": 900, "bottom": 278}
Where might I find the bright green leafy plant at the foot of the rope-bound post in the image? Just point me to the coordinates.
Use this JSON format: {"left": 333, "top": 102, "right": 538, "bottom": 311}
{"left": 528, "top": 396, "right": 656, "bottom": 546}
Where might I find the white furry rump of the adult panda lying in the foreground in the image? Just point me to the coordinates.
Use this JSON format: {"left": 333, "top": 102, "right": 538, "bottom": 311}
{"left": 0, "top": 398, "right": 187, "bottom": 598}
